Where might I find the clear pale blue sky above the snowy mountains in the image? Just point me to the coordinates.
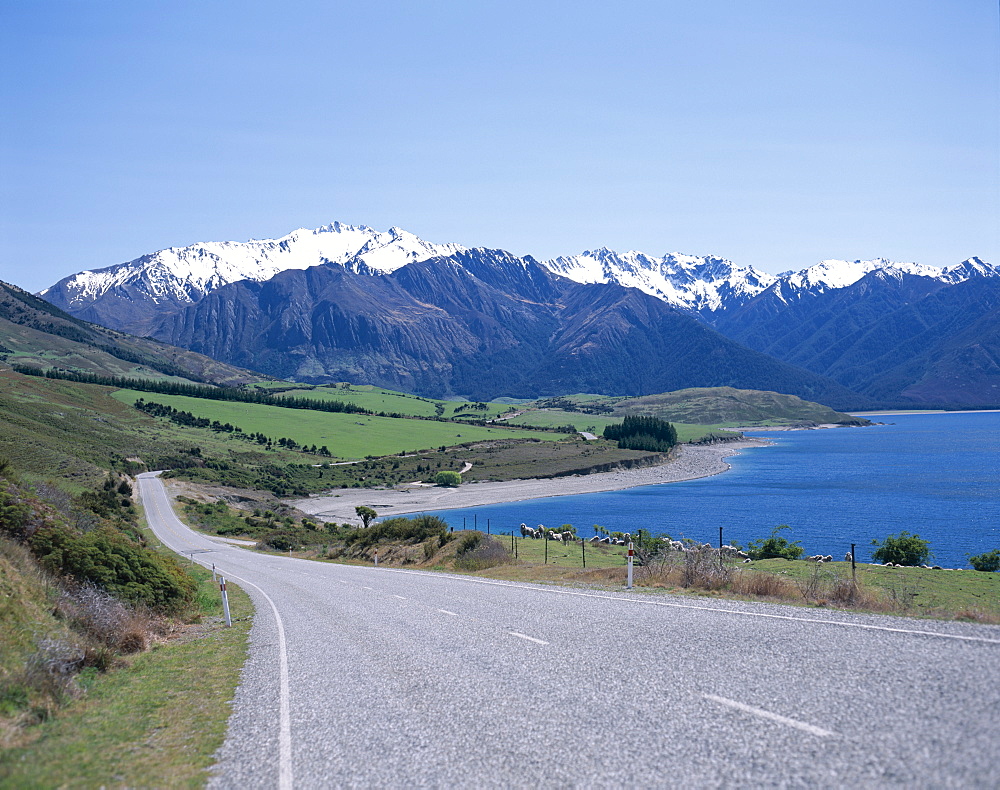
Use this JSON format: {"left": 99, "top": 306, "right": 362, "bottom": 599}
{"left": 0, "top": 0, "right": 1000, "bottom": 290}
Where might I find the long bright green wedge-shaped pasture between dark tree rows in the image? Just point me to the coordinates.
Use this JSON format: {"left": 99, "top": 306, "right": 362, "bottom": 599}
{"left": 114, "top": 390, "right": 560, "bottom": 459}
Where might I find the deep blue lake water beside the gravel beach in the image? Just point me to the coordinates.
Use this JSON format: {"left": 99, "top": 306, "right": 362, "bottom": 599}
{"left": 426, "top": 412, "right": 1000, "bottom": 568}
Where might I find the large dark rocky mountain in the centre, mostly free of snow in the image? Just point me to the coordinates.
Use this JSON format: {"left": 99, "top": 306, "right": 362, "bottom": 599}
{"left": 148, "top": 250, "right": 867, "bottom": 408}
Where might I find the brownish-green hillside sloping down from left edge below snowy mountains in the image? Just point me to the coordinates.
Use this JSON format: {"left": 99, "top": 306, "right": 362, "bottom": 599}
{"left": 0, "top": 282, "right": 265, "bottom": 385}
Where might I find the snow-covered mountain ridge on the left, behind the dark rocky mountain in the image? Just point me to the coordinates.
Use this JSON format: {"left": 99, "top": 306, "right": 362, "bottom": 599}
{"left": 39, "top": 222, "right": 464, "bottom": 331}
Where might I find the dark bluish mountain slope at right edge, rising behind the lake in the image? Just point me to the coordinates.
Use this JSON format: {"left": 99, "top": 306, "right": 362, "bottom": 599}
{"left": 714, "top": 271, "right": 1000, "bottom": 407}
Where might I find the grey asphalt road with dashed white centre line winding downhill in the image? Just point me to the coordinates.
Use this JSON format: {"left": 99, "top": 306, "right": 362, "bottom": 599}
{"left": 139, "top": 475, "right": 1000, "bottom": 788}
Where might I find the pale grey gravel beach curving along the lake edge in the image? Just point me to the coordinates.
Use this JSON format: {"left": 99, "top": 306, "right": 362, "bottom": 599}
{"left": 290, "top": 439, "right": 772, "bottom": 523}
